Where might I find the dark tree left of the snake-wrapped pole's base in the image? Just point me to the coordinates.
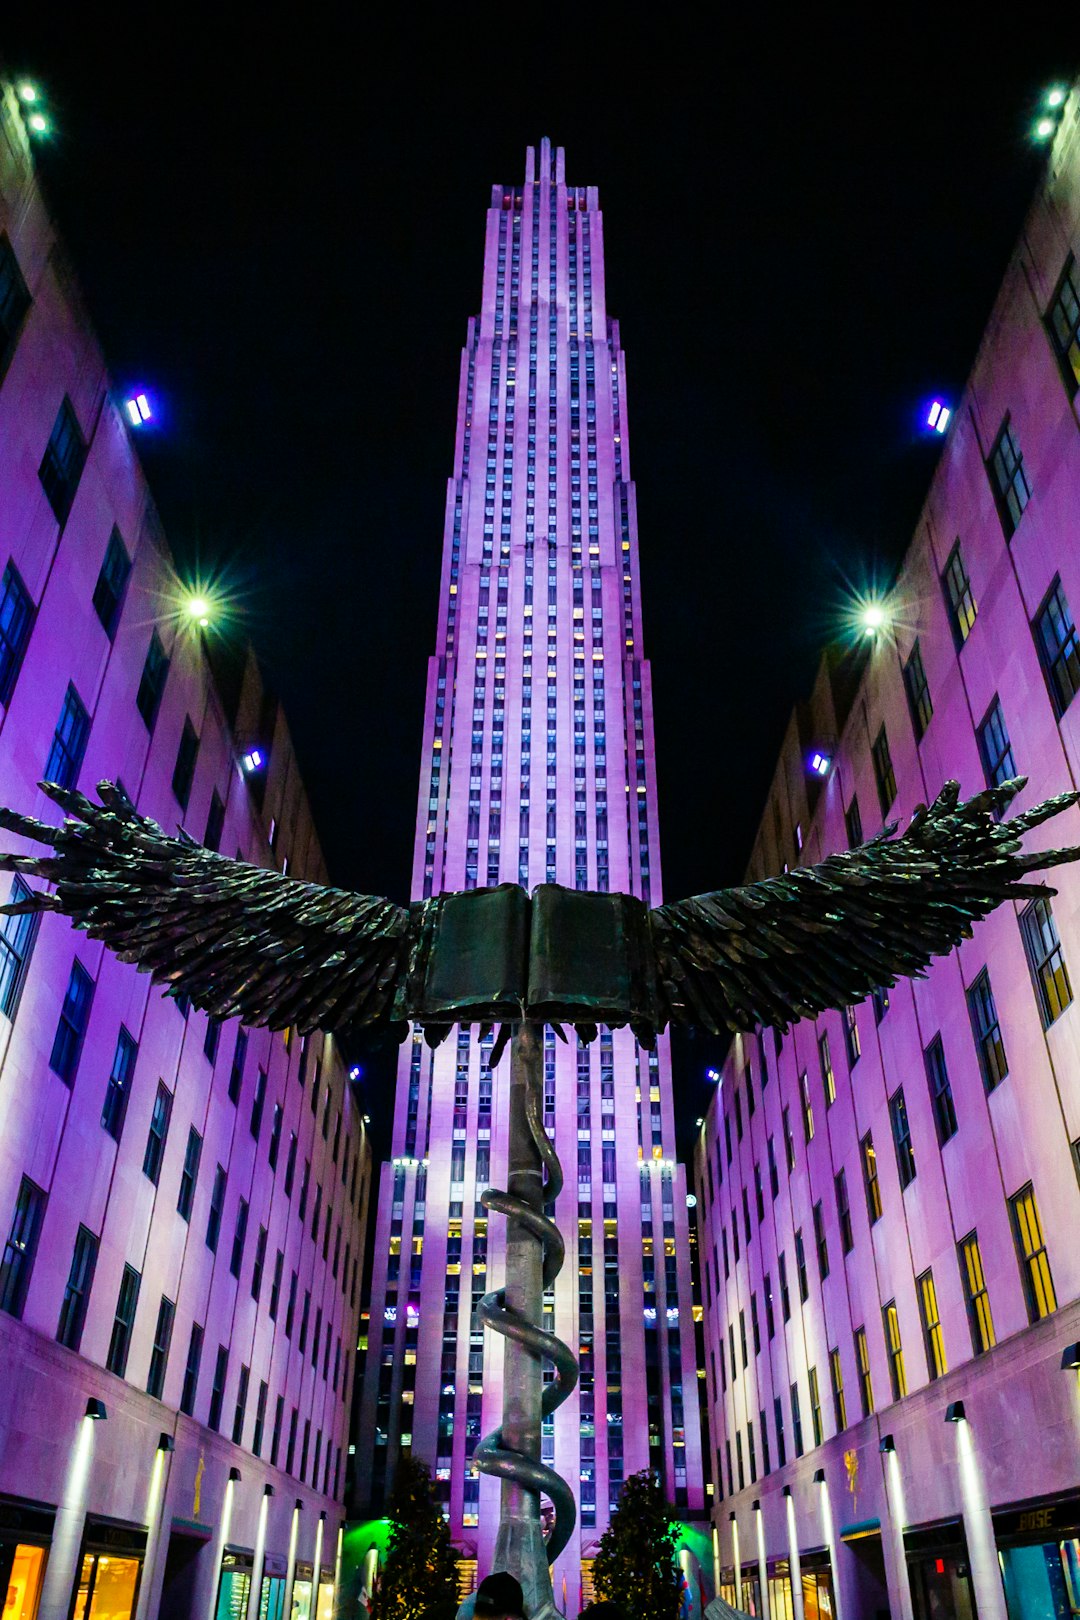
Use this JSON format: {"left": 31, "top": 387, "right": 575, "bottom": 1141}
{"left": 371, "top": 1456, "right": 457, "bottom": 1620}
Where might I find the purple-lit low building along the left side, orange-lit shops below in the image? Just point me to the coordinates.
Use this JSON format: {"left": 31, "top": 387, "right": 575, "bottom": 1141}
{"left": 0, "top": 83, "right": 371, "bottom": 1620}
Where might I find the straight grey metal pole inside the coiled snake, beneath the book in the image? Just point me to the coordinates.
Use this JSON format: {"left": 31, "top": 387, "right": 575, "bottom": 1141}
{"left": 494, "top": 1022, "right": 557, "bottom": 1620}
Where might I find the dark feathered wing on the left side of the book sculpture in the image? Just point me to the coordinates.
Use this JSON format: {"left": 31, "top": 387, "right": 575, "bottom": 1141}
{"left": 0, "top": 782, "right": 410, "bottom": 1032}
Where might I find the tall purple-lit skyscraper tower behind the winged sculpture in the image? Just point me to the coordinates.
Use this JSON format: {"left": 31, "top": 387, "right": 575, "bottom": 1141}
{"left": 358, "top": 141, "right": 703, "bottom": 1612}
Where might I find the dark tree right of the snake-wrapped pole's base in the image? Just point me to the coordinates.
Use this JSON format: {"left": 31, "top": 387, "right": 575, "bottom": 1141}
{"left": 593, "top": 1469, "right": 682, "bottom": 1620}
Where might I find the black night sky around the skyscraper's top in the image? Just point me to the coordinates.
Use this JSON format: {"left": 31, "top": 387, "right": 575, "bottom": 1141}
{"left": 0, "top": 6, "right": 1080, "bottom": 1153}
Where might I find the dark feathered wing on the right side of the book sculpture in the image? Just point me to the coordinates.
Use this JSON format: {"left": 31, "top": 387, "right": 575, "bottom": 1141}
{"left": 651, "top": 778, "right": 1080, "bottom": 1030}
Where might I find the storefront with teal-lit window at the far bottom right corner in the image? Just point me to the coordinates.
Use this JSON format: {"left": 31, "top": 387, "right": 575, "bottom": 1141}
{"left": 994, "top": 1492, "right": 1080, "bottom": 1620}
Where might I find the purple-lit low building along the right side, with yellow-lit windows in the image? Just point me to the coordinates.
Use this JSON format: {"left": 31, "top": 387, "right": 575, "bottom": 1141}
{"left": 695, "top": 89, "right": 1080, "bottom": 1620}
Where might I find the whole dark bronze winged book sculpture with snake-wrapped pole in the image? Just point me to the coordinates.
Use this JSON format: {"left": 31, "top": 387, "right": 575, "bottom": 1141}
{"left": 0, "top": 778, "right": 1080, "bottom": 1620}
